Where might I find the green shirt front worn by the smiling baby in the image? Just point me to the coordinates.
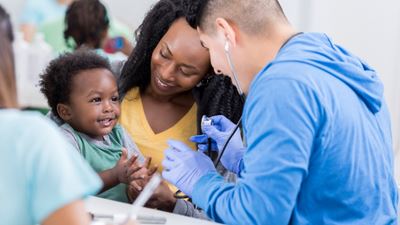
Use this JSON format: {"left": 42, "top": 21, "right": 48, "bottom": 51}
{"left": 62, "top": 124, "right": 128, "bottom": 202}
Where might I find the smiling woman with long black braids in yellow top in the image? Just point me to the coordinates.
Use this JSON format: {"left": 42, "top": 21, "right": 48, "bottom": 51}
{"left": 120, "top": 0, "right": 242, "bottom": 217}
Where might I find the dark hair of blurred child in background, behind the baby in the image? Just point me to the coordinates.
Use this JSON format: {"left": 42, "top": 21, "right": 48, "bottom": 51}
{"left": 64, "top": 0, "right": 110, "bottom": 48}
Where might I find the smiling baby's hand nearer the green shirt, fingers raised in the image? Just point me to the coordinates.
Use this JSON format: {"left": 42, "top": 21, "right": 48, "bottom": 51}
{"left": 113, "top": 148, "right": 138, "bottom": 184}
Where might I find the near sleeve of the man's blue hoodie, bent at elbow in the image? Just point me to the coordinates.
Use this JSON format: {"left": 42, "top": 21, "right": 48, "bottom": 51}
{"left": 193, "top": 79, "right": 324, "bottom": 224}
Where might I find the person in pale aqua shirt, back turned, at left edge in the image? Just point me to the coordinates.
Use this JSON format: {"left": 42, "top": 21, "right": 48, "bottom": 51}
{"left": 0, "top": 6, "right": 136, "bottom": 225}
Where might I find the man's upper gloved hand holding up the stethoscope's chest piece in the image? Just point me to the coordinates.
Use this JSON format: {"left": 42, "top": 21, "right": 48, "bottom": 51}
{"left": 190, "top": 115, "right": 246, "bottom": 174}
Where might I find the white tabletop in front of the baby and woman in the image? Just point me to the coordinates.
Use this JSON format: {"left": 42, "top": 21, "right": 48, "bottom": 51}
{"left": 85, "top": 196, "right": 222, "bottom": 225}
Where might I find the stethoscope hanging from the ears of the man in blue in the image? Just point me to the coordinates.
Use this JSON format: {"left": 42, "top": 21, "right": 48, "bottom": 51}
{"left": 174, "top": 41, "right": 245, "bottom": 199}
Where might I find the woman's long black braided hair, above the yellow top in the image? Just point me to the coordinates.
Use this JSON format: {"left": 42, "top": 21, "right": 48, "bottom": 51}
{"left": 118, "top": 0, "right": 243, "bottom": 132}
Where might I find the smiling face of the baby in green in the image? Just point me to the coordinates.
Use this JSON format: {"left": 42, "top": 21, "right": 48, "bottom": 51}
{"left": 66, "top": 69, "right": 120, "bottom": 140}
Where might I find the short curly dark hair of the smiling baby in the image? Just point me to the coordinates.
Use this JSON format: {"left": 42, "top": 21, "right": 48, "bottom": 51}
{"left": 39, "top": 50, "right": 111, "bottom": 119}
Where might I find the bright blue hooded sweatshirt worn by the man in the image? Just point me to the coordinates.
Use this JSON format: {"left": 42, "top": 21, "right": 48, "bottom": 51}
{"left": 193, "top": 33, "right": 398, "bottom": 225}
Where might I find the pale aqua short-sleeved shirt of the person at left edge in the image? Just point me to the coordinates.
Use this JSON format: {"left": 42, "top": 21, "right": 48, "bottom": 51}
{"left": 0, "top": 109, "right": 102, "bottom": 224}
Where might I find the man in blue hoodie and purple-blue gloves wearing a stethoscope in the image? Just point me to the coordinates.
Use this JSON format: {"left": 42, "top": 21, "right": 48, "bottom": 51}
{"left": 162, "top": 0, "right": 398, "bottom": 224}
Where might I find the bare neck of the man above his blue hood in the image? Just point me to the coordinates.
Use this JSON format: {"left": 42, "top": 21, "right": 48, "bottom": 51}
{"left": 241, "top": 24, "right": 297, "bottom": 81}
